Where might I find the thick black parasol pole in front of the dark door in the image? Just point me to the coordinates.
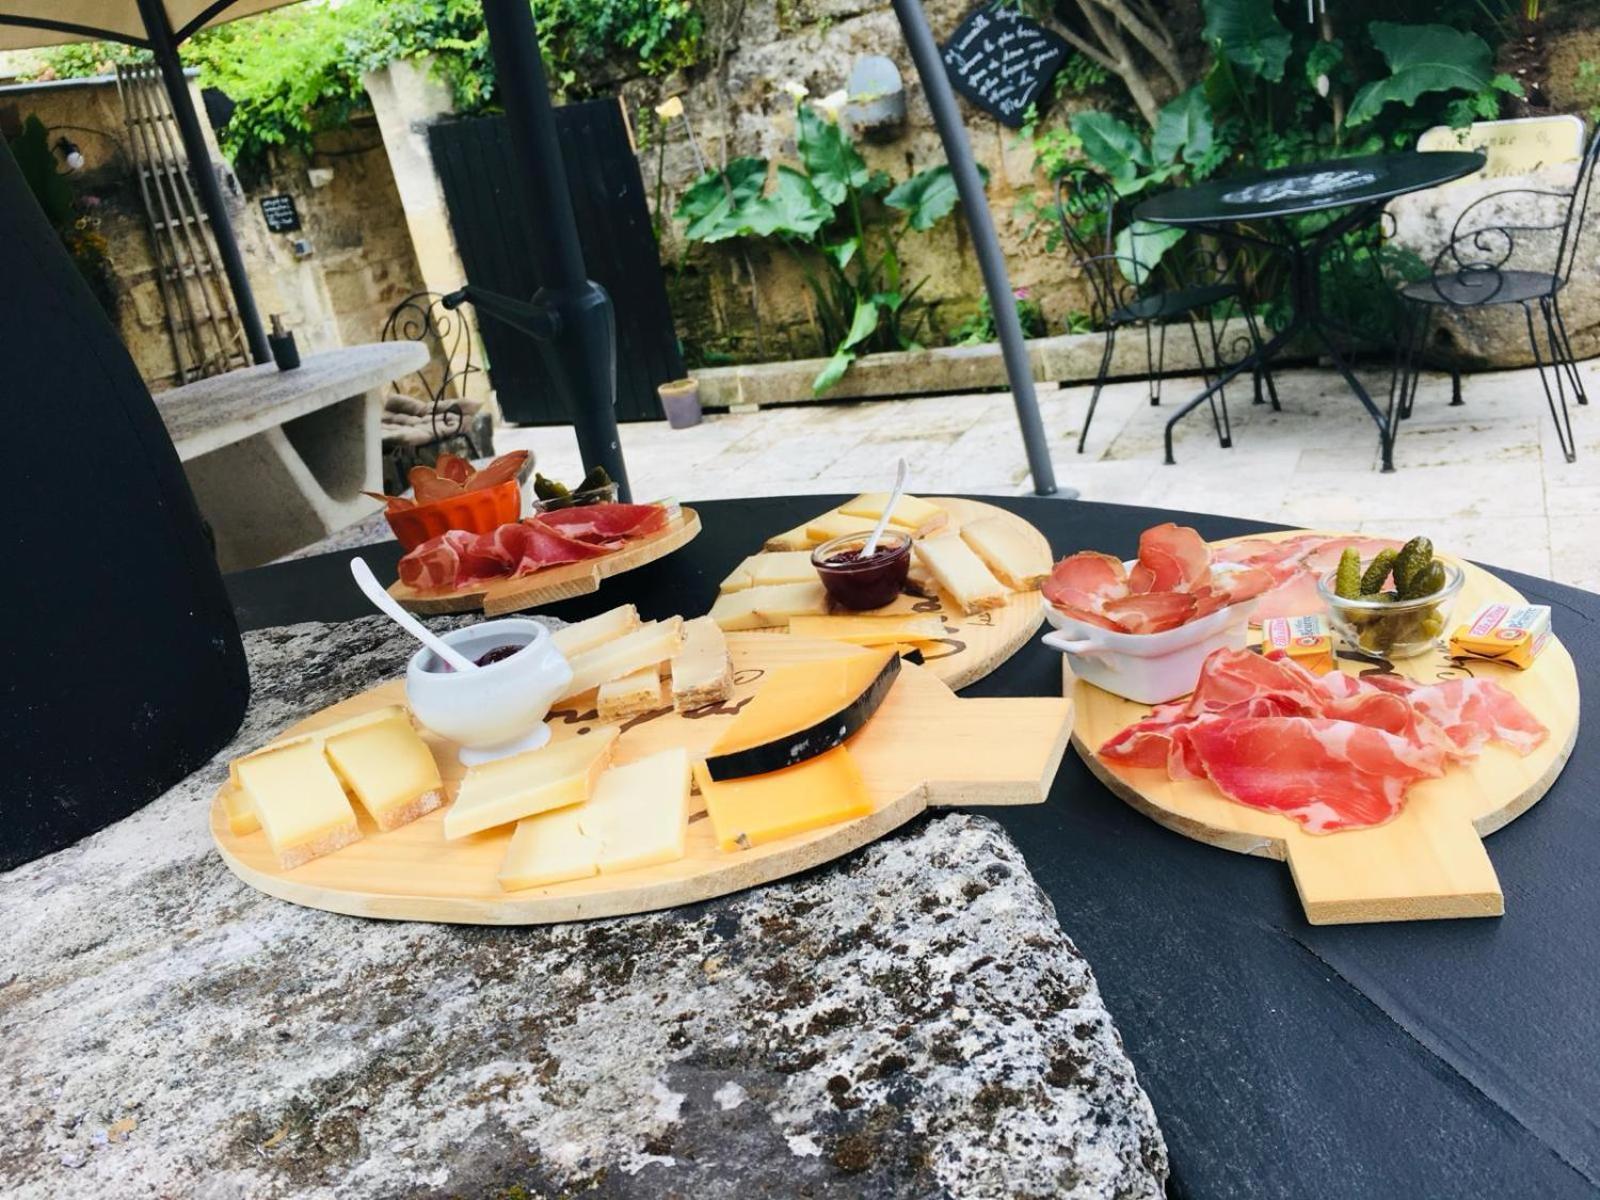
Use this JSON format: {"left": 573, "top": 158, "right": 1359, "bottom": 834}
{"left": 483, "top": 0, "right": 630, "bottom": 499}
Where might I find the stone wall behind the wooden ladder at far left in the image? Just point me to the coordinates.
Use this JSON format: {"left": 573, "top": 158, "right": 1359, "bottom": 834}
{"left": 0, "top": 80, "right": 422, "bottom": 389}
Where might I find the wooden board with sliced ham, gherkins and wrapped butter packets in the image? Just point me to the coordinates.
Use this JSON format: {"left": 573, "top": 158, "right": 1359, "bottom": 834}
{"left": 1045, "top": 526, "right": 1579, "bottom": 925}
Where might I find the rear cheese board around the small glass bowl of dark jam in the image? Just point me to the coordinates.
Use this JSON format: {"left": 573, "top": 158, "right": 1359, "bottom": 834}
{"left": 710, "top": 493, "right": 1051, "bottom": 690}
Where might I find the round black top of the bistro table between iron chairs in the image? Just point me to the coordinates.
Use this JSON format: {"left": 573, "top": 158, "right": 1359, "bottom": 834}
{"left": 1133, "top": 150, "right": 1485, "bottom": 226}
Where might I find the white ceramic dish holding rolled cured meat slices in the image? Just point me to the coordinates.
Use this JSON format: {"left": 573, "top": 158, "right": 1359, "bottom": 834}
{"left": 1040, "top": 563, "right": 1256, "bottom": 704}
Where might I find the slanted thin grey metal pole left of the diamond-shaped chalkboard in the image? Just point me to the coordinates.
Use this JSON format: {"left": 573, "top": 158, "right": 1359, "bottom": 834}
{"left": 894, "top": 0, "right": 1078, "bottom": 499}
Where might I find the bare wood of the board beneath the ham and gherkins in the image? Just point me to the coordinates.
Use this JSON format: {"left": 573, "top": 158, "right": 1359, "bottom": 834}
{"left": 1062, "top": 531, "right": 1578, "bottom": 925}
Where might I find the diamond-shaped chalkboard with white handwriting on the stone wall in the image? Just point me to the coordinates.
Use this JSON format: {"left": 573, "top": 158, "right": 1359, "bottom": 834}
{"left": 944, "top": 3, "right": 1072, "bottom": 130}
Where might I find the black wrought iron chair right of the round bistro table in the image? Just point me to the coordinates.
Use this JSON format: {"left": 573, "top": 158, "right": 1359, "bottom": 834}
{"left": 1389, "top": 122, "right": 1600, "bottom": 462}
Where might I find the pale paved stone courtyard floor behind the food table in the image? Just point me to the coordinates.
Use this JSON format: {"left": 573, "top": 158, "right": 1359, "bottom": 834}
{"left": 496, "top": 362, "right": 1600, "bottom": 590}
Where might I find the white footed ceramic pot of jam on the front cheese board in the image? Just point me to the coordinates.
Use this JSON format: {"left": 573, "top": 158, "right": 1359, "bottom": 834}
{"left": 405, "top": 618, "right": 573, "bottom": 766}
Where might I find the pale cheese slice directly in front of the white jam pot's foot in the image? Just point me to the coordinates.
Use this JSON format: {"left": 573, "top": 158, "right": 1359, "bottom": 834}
{"left": 445, "top": 725, "right": 616, "bottom": 840}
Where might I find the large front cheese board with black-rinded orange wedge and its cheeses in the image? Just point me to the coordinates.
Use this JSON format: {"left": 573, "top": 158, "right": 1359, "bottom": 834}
{"left": 210, "top": 606, "right": 1072, "bottom": 925}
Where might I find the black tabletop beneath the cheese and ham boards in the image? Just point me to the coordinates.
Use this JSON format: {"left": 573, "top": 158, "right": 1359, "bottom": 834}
{"left": 229, "top": 496, "right": 1600, "bottom": 1200}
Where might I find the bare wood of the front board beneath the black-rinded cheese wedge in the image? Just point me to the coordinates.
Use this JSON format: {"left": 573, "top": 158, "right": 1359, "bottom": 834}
{"left": 211, "top": 634, "right": 1072, "bottom": 925}
